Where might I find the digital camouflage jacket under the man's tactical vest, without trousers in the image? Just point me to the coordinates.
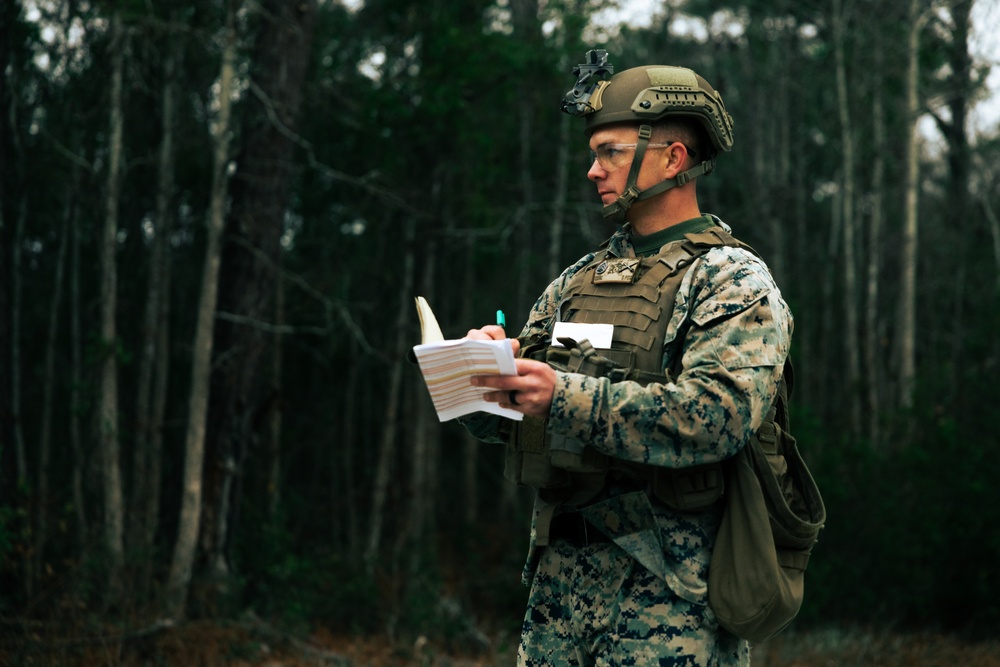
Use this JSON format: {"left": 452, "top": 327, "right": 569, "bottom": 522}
{"left": 463, "top": 217, "right": 792, "bottom": 604}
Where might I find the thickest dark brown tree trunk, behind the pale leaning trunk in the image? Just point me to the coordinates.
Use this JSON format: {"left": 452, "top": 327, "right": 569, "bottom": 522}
{"left": 200, "top": 0, "right": 316, "bottom": 611}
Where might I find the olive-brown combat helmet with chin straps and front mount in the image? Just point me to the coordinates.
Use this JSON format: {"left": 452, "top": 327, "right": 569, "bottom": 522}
{"left": 562, "top": 49, "right": 733, "bottom": 223}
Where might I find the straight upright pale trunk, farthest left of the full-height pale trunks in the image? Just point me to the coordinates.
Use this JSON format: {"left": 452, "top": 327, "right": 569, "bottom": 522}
{"left": 98, "top": 11, "right": 125, "bottom": 601}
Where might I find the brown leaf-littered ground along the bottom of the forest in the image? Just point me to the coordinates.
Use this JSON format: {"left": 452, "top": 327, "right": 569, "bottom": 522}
{"left": 0, "top": 619, "right": 1000, "bottom": 667}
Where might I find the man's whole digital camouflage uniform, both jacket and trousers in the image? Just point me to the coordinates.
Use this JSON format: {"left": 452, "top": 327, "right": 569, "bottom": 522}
{"left": 465, "top": 216, "right": 792, "bottom": 666}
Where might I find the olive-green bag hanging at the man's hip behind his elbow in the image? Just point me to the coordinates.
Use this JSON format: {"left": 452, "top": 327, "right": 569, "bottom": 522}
{"left": 708, "top": 361, "right": 826, "bottom": 642}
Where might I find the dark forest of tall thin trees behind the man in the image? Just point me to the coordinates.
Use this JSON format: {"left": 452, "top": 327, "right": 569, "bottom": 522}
{"left": 0, "top": 0, "right": 1000, "bottom": 664}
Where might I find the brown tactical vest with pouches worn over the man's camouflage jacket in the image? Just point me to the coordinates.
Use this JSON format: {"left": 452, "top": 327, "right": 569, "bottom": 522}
{"left": 504, "top": 227, "right": 753, "bottom": 511}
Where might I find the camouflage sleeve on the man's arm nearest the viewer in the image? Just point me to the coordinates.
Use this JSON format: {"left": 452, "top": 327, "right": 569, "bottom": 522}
{"left": 549, "top": 248, "right": 792, "bottom": 468}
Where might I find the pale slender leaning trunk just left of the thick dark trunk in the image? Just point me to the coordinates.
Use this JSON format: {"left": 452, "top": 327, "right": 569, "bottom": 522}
{"left": 164, "top": 0, "right": 237, "bottom": 619}
